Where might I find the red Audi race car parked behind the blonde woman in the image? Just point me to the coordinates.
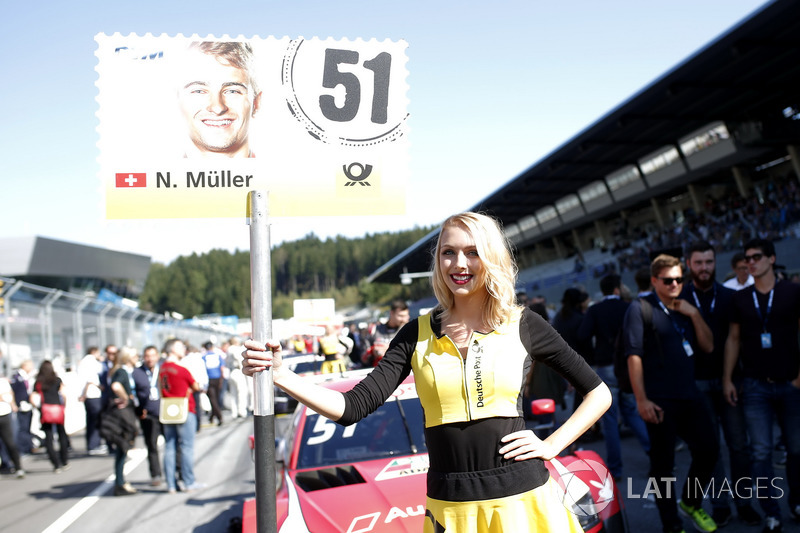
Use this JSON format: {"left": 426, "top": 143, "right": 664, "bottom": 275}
{"left": 242, "top": 373, "right": 627, "bottom": 533}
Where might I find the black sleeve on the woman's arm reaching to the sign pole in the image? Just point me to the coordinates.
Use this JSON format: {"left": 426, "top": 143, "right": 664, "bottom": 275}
{"left": 338, "top": 319, "right": 419, "bottom": 426}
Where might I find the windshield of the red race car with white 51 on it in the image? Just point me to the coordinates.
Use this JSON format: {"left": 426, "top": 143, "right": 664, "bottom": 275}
{"left": 297, "top": 384, "right": 428, "bottom": 468}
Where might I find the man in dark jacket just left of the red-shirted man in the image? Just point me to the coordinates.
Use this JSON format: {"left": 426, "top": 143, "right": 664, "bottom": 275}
{"left": 133, "top": 346, "right": 161, "bottom": 487}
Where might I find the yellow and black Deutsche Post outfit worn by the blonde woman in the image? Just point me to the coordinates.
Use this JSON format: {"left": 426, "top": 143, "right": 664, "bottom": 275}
{"left": 339, "top": 308, "right": 601, "bottom": 533}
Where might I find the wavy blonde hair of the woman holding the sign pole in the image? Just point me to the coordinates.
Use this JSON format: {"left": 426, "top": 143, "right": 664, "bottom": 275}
{"left": 431, "top": 212, "right": 521, "bottom": 329}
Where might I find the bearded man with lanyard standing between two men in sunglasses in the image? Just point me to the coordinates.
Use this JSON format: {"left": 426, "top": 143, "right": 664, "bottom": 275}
{"left": 680, "top": 241, "right": 761, "bottom": 527}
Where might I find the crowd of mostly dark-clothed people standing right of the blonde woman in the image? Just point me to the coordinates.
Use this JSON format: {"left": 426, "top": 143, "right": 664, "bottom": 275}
{"left": 520, "top": 237, "right": 800, "bottom": 532}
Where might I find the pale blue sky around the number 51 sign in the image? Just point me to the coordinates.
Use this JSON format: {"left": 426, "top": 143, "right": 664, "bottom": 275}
{"left": 0, "top": 0, "right": 765, "bottom": 263}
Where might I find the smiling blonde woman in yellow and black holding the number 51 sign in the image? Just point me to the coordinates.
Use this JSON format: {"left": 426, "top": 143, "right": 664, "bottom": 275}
{"left": 245, "top": 213, "right": 611, "bottom": 533}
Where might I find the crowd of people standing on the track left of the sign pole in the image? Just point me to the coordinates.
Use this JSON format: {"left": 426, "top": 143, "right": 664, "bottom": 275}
{"left": 0, "top": 337, "right": 252, "bottom": 496}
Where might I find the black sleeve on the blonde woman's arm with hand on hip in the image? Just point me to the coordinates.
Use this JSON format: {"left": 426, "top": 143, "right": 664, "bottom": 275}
{"left": 520, "top": 308, "right": 603, "bottom": 396}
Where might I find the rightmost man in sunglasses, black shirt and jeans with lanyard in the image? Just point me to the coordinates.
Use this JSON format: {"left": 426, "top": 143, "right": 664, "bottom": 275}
{"left": 722, "top": 239, "right": 800, "bottom": 531}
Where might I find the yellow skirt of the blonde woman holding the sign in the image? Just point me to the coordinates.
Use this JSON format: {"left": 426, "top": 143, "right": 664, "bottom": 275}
{"left": 423, "top": 478, "right": 583, "bottom": 533}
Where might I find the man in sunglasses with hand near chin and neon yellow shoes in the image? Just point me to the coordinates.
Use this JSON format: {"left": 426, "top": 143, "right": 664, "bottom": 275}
{"left": 623, "top": 254, "right": 719, "bottom": 533}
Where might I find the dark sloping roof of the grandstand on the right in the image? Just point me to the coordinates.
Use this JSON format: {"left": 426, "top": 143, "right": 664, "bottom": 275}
{"left": 369, "top": 0, "right": 800, "bottom": 283}
